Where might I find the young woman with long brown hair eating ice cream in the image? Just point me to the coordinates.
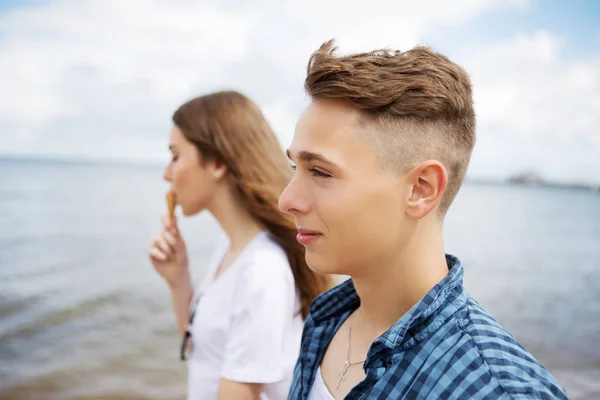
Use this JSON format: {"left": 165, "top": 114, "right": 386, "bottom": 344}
{"left": 149, "top": 92, "right": 331, "bottom": 400}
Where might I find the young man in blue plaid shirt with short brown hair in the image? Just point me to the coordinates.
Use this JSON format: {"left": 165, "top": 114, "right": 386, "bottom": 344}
{"left": 279, "top": 41, "right": 566, "bottom": 400}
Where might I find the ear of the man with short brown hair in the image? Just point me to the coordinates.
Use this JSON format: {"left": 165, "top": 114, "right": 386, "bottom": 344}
{"left": 406, "top": 160, "right": 448, "bottom": 219}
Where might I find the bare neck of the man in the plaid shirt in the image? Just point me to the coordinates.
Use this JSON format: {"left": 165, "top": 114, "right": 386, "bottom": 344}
{"left": 352, "top": 227, "right": 448, "bottom": 340}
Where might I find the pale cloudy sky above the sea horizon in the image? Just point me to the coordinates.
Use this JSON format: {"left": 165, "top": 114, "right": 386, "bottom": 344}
{"left": 0, "top": 0, "right": 600, "bottom": 184}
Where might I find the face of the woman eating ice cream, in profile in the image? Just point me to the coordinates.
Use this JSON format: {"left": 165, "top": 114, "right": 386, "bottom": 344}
{"left": 164, "top": 125, "right": 222, "bottom": 215}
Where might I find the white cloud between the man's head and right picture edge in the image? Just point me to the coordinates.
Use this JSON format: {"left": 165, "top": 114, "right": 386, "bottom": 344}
{"left": 461, "top": 31, "right": 600, "bottom": 182}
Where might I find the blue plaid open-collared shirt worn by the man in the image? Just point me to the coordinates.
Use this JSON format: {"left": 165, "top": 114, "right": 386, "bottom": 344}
{"left": 289, "top": 255, "right": 567, "bottom": 400}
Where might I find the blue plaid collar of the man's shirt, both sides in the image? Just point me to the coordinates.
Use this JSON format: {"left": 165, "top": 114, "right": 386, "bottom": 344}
{"left": 311, "top": 254, "right": 464, "bottom": 346}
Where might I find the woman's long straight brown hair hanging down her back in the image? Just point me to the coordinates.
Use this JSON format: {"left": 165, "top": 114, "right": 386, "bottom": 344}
{"left": 173, "top": 91, "right": 332, "bottom": 318}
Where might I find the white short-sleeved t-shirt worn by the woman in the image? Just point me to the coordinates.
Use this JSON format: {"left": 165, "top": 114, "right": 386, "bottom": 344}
{"left": 188, "top": 232, "right": 304, "bottom": 400}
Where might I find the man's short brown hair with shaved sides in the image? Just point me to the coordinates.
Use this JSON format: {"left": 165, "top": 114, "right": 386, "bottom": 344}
{"left": 305, "top": 40, "right": 475, "bottom": 215}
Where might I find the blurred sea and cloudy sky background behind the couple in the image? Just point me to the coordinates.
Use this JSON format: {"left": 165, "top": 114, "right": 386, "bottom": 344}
{"left": 0, "top": 0, "right": 600, "bottom": 400}
